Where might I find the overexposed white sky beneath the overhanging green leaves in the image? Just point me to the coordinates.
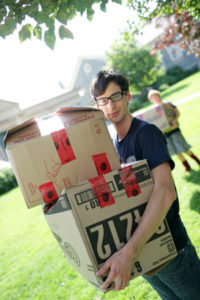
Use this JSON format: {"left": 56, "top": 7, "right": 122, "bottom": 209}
{"left": 0, "top": 2, "right": 158, "bottom": 109}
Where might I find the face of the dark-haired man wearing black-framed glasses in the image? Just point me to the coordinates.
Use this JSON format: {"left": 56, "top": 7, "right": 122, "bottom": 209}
{"left": 97, "top": 82, "right": 131, "bottom": 124}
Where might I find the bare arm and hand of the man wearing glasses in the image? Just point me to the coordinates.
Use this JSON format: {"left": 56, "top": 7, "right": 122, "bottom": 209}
{"left": 97, "top": 162, "right": 177, "bottom": 291}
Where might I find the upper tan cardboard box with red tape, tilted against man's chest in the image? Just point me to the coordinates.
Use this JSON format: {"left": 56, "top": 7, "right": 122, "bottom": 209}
{"left": 5, "top": 107, "right": 120, "bottom": 208}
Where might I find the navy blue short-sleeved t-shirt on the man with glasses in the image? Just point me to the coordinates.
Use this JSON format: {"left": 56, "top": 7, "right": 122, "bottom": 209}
{"left": 113, "top": 118, "right": 188, "bottom": 250}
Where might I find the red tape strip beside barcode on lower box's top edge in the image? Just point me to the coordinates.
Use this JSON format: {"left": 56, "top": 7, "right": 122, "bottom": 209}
{"left": 89, "top": 175, "right": 115, "bottom": 208}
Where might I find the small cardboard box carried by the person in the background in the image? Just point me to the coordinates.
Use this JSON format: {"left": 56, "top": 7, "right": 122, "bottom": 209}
{"left": 134, "top": 103, "right": 178, "bottom": 132}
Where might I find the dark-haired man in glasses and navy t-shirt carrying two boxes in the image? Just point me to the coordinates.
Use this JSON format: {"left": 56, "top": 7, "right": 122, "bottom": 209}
{"left": 91, "top": 71, "right": 200, "bottom": 300}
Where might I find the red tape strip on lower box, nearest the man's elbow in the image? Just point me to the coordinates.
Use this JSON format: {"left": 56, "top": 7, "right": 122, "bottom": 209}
{"left": 120, "top": 166, "right": 141, "bottom": 197}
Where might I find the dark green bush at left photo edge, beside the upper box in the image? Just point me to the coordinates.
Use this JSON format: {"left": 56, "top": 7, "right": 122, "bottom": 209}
{"left": 0, "top": 168, "right": 18, "bottom": 195}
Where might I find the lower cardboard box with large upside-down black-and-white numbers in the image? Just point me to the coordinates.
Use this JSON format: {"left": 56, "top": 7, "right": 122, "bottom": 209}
{"left": 44, "top": 160, "right": 176, "bottom": 288}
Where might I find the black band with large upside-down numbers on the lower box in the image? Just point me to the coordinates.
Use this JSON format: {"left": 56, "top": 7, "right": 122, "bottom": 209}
{"left": 86, "top": 203, "right": 169, "bottom": 264}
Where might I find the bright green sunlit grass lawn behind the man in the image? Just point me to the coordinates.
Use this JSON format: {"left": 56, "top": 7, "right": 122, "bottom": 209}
{"left": 0, "top": 72, "right": 200, "bottom": 300}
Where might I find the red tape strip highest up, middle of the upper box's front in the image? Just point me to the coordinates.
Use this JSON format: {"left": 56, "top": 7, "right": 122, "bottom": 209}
{"left": 51, "top": 129, "right": 76, "bottom": 165}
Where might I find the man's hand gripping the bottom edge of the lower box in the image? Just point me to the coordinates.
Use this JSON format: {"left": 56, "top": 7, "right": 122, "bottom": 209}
{"left": 96, "top": 246, "right": 133, "bottom": 291}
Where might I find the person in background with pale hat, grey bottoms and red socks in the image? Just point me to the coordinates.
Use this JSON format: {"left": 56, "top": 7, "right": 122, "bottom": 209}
{"left": 148, "top": 90, "right": 200, "bottom": 172}
